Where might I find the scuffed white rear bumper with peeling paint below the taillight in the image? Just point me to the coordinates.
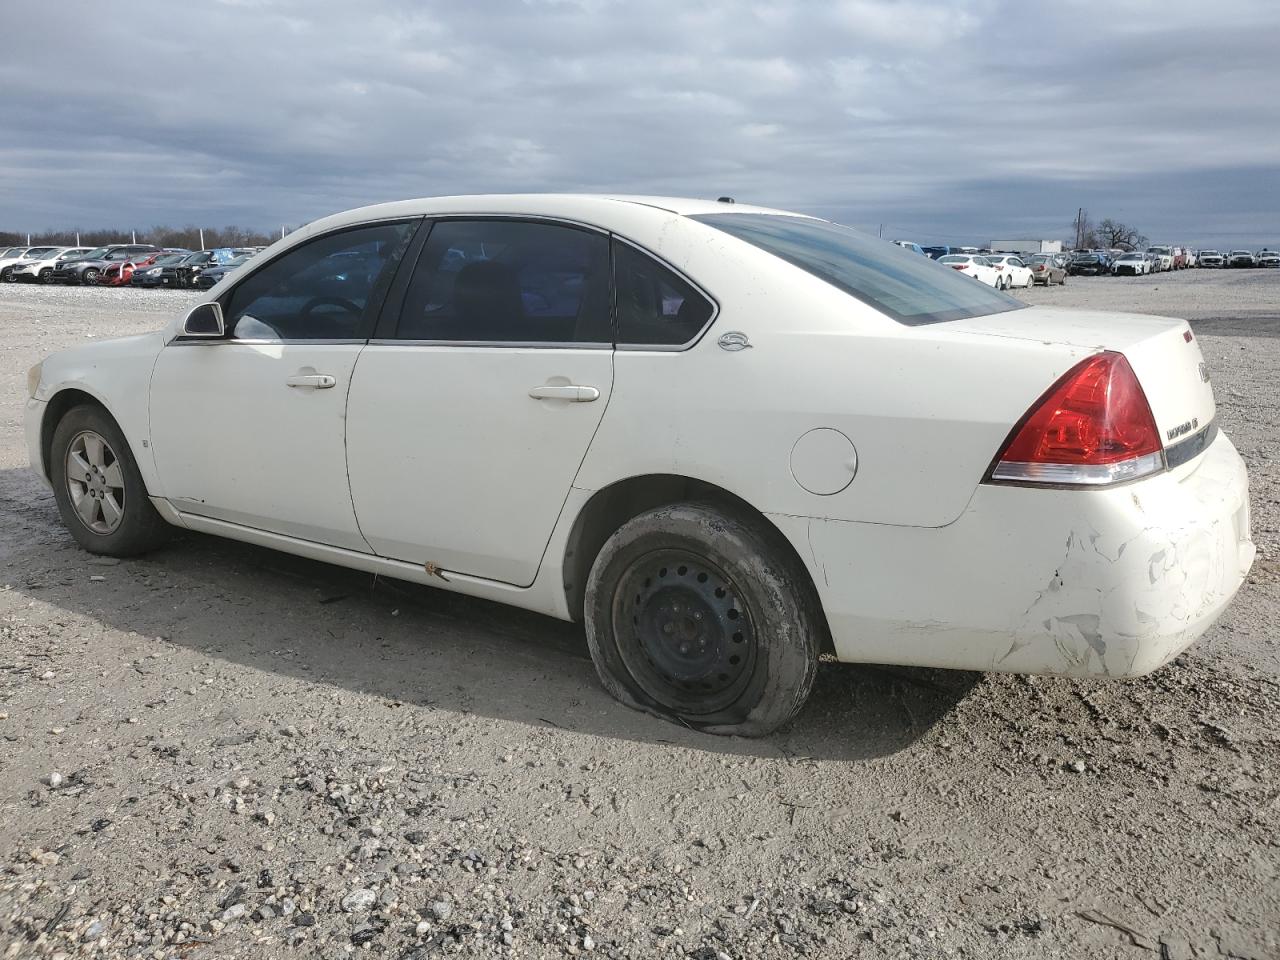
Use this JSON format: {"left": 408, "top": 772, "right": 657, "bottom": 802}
{"left": 772, "top": 433, "right": 1254, "bottom": 677}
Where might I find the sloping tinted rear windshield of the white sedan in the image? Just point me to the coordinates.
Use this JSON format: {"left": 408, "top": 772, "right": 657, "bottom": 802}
{"left": 691, "top": 214, "right": 1025, "bottom": 326}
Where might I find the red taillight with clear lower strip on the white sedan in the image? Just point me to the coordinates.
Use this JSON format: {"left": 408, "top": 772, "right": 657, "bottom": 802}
{"left": 991, "top": 352, "right": 1165, "bottom": 486}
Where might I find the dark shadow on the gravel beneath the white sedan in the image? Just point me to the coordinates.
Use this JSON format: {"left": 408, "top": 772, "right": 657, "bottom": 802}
{"left": 0, "top": 470, "right": 982, "bottom": 760}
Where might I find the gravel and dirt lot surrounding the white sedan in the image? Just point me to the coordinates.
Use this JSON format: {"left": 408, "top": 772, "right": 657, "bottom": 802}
{"left": 0, "top": 271, "right": 1280, "bottom": 960}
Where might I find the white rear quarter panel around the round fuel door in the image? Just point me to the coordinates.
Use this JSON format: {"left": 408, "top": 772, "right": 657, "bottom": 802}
{"left": 576, "top": 228, "right": 1093, "bottom": 526}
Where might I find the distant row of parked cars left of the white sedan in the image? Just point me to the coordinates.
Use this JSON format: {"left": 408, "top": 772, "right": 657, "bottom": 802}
{"left": 0, "top": 243, "right": 261, "bottom": 289}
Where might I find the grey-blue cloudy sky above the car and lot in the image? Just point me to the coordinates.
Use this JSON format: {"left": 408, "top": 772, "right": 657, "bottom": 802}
{"left": 0, "top": 0, "right": 1280, "bottom": 247}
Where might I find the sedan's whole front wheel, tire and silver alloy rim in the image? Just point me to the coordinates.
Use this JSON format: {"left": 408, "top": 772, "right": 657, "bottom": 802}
{"left": 49, "top": 404, "right": 172, "bottom": 557}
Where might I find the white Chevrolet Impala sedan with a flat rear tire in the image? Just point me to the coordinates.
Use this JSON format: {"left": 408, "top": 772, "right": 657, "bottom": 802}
{"left": 26, "top": 196, "right": 1253, "bottom": 735}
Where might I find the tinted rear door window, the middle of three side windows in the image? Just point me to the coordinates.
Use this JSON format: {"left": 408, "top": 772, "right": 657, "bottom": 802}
{"left": 396, "top": 220, "right": 612, "bottom": 344}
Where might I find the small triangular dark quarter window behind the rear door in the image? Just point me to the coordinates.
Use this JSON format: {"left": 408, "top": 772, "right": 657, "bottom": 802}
{"left": 613, "top": 241, "right": 716, "bottom": 347}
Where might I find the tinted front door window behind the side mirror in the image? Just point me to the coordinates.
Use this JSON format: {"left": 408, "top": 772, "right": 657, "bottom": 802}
{"left": 223, "top": 223, "right": 416, "bottom": 340}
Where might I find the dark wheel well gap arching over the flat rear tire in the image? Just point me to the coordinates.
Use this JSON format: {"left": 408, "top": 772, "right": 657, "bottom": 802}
{"left": 563, "top": 474, "right": 832, "bottom": 653}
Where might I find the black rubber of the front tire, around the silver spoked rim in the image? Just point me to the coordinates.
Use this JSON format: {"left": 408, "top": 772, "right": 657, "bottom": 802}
{"left": 49, "top": 404, "right": 173, "bottom": 557}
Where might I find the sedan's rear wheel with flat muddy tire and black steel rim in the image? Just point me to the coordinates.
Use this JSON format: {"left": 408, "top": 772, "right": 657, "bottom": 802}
{"left": 585, "top": 503, "right": 826, "bottom": 737}
